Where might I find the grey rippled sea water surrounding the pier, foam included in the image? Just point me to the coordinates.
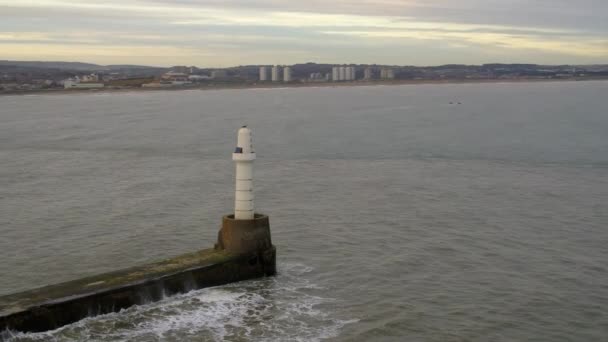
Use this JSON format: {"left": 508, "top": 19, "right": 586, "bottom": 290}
{"left": 0, "top": 82, "right": 608, "bottom": 341}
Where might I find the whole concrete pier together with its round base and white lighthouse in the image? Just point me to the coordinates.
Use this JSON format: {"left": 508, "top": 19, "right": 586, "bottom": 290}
{"left": 0, "top": 128, "right": 276, "bottom": 340}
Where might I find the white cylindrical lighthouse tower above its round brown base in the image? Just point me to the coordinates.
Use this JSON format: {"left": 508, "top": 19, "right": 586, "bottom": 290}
{"left": 232, "top": 126, "right": 255, "bottom": 220}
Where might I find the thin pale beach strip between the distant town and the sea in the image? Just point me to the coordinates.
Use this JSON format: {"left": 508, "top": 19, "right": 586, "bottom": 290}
{"left": 0, "top": 77, "right": 608, "bottom": 97}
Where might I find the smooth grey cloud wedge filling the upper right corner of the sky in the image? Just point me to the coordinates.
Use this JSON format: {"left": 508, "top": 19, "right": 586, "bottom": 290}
{"left": 145, "top": 0, "right": 608, "bottom": 33}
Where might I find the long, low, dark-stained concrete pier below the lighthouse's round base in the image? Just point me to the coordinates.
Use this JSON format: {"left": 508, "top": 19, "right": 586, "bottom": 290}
{"left": 0, "top": 247, "right": 276, "bottom": 340}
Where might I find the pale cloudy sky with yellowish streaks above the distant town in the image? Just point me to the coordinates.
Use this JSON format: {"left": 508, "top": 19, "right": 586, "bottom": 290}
{"left": 0, "top": 0, "right": 608, "bottom": 67}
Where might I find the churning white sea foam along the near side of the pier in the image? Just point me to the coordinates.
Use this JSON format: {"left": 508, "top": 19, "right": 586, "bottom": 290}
{"left": 5, "top": 264, "right": 355, "bottom": 342}
